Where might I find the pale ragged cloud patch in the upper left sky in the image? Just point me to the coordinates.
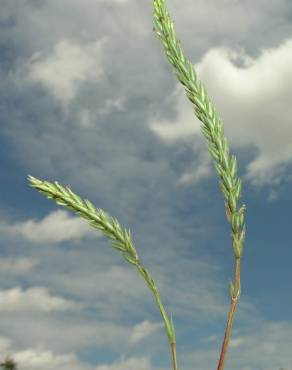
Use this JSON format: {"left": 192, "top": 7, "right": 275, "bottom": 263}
{"left": 28, "top": 38, "right": 106, "bottom": 106}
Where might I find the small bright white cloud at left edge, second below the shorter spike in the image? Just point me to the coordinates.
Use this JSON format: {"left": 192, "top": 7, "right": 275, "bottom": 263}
{"left": 0, "top": 287, "right": 81, "bottom": 312}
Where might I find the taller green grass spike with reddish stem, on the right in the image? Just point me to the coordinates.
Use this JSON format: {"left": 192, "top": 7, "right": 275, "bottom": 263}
{"left": 153, "top": 0, "right": 246, "bottom": 370}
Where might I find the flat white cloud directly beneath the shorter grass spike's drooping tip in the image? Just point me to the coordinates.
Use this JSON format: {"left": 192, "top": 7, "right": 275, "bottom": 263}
{"left": 0, "top": 210, "right": 101, "bottom": 243}
